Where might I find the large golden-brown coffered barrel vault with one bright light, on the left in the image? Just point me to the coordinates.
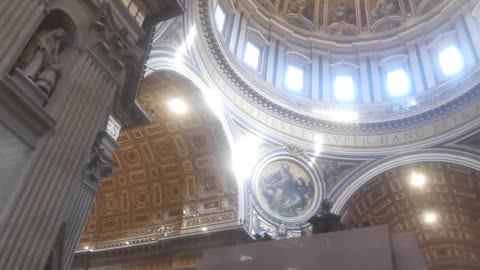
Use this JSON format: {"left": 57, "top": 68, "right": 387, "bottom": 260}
{"left": 80, "top": 72, "right": 238, "bottom": 248}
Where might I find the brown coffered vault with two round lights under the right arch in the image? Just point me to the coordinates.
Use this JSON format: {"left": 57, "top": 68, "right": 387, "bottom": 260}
{"left": 343, "top": 163, "right": 480, "bottom": 270}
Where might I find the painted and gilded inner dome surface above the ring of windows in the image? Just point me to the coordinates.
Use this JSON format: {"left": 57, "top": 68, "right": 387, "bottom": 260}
{"left": 249, "top": 0, "right": 445, "bottom": 36}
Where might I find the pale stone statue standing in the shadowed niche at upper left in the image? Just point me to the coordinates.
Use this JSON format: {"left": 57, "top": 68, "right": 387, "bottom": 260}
{"left": 18, "top": 28, "right": 65, "bottom": 95}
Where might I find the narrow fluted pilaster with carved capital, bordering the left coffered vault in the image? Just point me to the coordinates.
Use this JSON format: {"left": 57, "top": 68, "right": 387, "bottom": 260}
{"left": 61, "top": 132, "right": 117, "bottom": 270}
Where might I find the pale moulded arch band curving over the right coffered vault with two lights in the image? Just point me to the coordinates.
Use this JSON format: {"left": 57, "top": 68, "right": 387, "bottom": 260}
{"left": 329, "top": 149, "right": 480, "bottom": 214}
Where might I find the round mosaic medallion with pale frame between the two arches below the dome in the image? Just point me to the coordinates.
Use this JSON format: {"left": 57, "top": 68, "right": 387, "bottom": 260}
{"left": 253, "top": 157, "right": 320, "bottom": 223}
